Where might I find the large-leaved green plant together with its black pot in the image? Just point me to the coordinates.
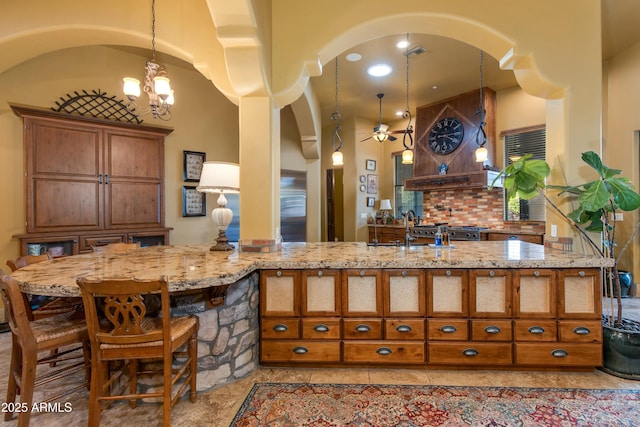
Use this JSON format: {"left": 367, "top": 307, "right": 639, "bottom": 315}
{"left": 492, "top": 151, "right": 640, "bottom": 379}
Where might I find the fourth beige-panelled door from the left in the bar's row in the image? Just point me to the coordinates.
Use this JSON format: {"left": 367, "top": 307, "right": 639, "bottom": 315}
{"left": 382, "top": 270, "right": 427, "bottom": 317}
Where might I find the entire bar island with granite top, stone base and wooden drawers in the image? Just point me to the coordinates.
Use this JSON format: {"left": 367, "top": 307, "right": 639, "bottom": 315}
{"left": 8, "top": 241, "right": 608, "bottom": 390}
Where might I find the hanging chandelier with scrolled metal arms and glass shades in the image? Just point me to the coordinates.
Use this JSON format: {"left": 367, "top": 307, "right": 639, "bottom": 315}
{"left": 122, "top": 0, "right": 173, "bottom": 120}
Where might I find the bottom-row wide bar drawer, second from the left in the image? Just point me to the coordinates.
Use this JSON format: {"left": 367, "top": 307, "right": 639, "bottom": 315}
{"left": 343, "top": 341, "right": 425, "bottom": 365}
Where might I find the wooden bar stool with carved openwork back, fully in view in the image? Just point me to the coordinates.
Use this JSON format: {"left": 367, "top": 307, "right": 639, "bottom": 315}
{"left": 77, "top": 277, "right": 199, "bottom": 427}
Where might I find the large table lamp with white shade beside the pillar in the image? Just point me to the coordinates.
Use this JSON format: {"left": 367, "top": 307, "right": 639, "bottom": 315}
{"left": 196, "top": 162, "right": 240, "bottom": 251}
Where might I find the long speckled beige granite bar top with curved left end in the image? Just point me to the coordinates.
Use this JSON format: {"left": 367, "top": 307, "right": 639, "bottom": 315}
{"left": 12, "top": 241, "right": 613, "bottom": 296}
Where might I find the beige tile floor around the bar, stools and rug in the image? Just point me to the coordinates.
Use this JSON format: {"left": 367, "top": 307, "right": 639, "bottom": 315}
{"left": 0, "top": 298, "right": 640, "bottom": 427}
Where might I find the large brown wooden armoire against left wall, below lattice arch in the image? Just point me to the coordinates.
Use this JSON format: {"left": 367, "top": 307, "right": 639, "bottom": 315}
{"left": 12, "top": 106, "right": 172, "bottom": 253}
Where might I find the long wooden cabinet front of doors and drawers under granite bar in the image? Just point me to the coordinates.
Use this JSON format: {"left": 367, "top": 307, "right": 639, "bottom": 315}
{"left": 260, "top": 268, "right": 602, "bottom": 369}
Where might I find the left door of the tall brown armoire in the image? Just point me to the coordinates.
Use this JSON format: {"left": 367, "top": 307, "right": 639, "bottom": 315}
{"left": 24, "top": 117, "right": 103, "bottom": 233}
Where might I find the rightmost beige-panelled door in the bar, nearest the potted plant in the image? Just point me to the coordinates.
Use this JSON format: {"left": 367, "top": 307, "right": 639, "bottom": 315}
{"left": 558, "top": 268, "right": 602, "bottom": 319}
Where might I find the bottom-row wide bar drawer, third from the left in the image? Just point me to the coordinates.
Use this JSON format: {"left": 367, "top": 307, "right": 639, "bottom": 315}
{"left": 427, "top": 342, "right": 512, "bottom": 365}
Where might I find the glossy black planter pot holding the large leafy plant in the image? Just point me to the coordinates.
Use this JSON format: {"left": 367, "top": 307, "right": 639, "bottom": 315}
{"left": 602, "top": 320, "right": 640, "bottom": 380}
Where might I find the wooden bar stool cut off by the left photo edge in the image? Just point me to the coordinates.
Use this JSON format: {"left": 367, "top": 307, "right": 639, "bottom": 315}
{"left": 0, "top": 275, "right": 91, "bottom": 427}
